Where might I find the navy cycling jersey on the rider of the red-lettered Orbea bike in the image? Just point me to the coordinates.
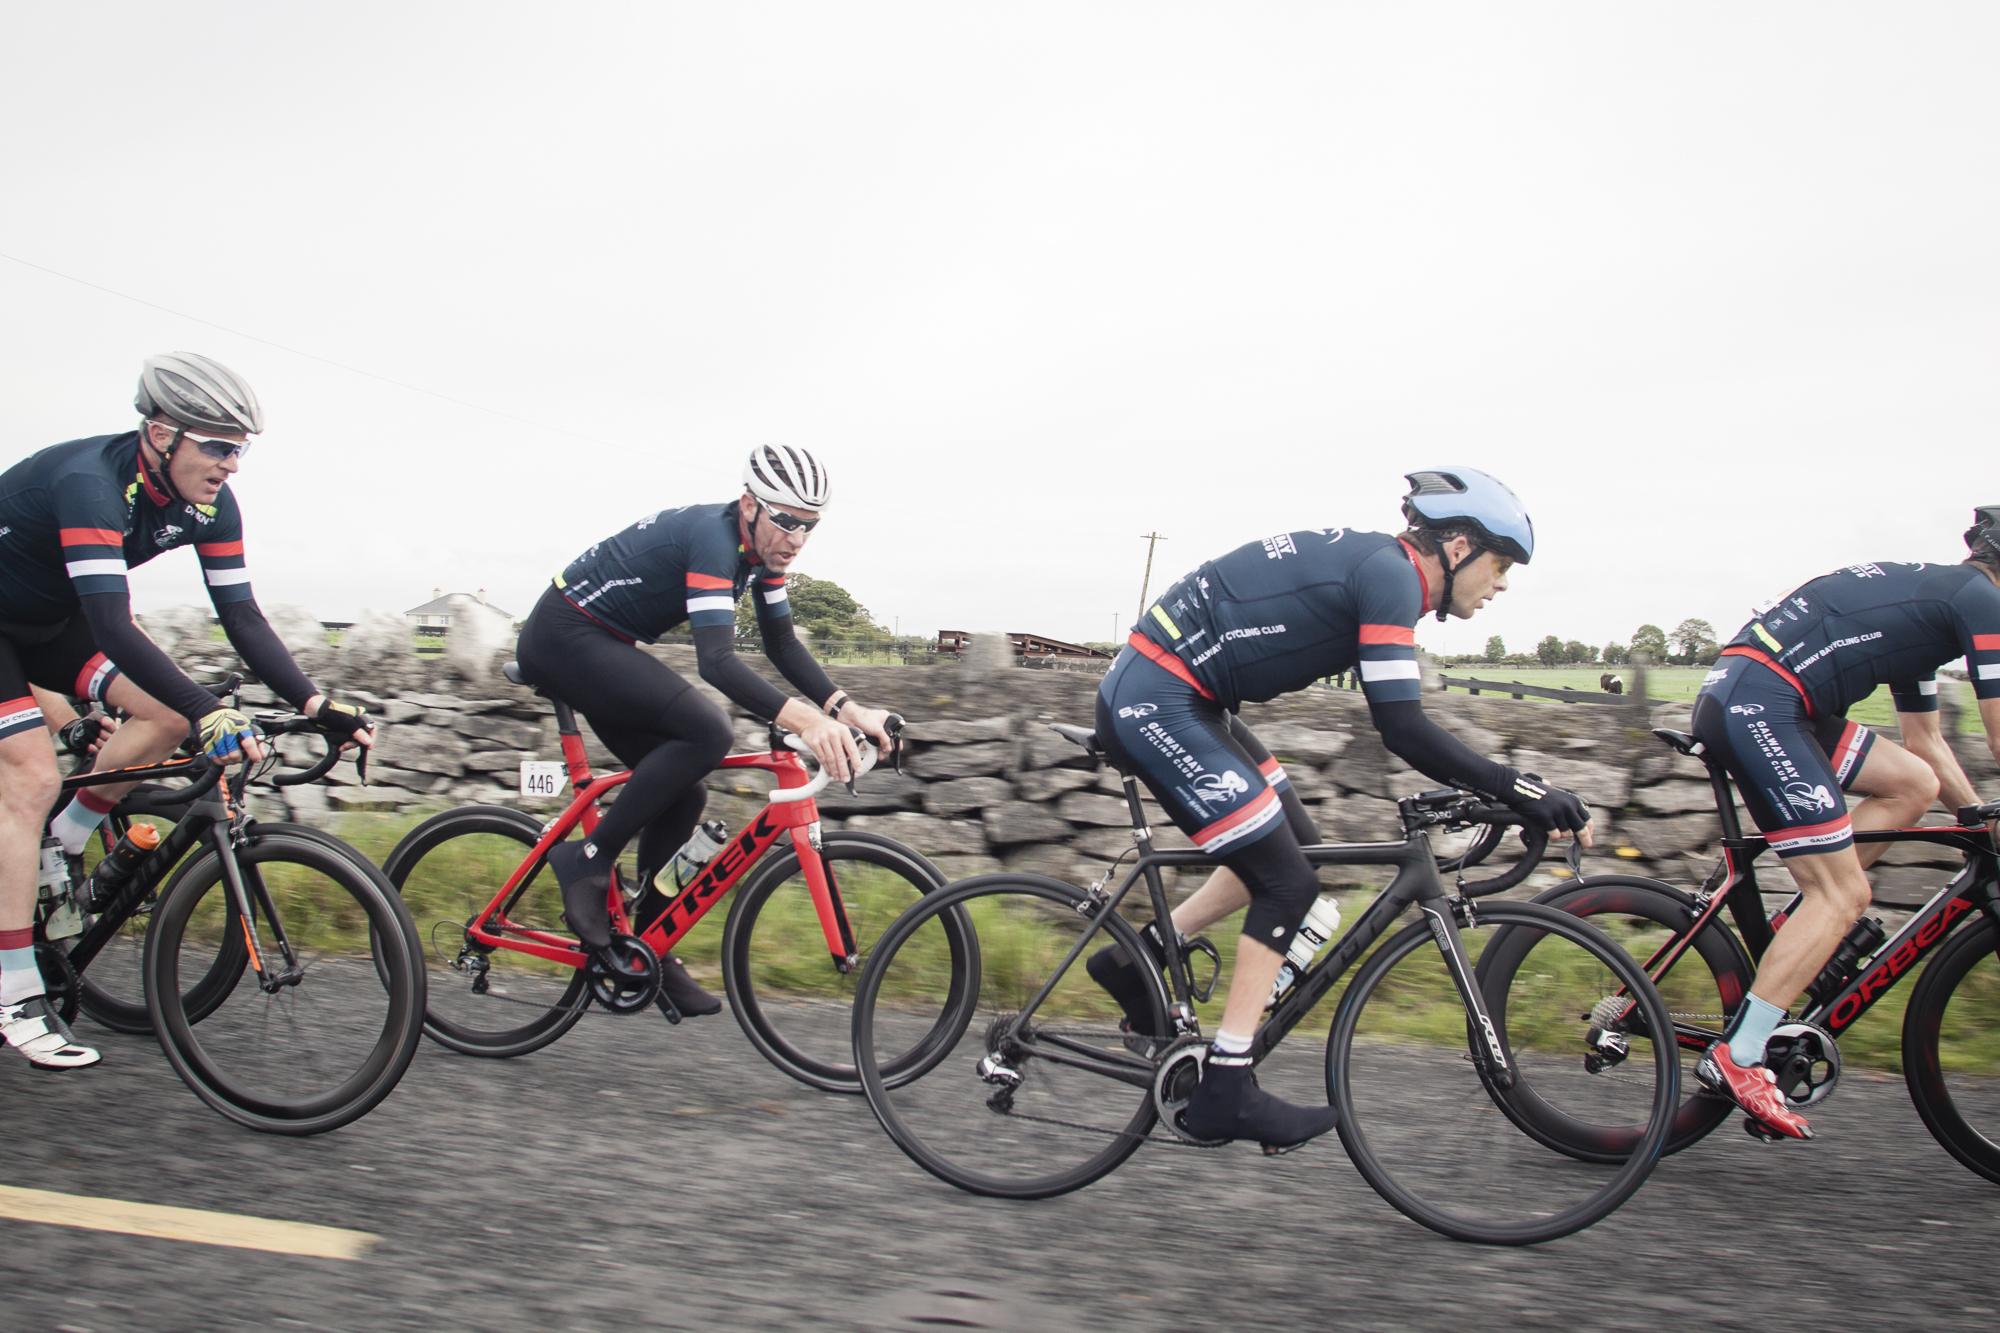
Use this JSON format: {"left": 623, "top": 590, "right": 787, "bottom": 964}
{"left": 1712, "top": 562, "right": 2000, "bottom": 717}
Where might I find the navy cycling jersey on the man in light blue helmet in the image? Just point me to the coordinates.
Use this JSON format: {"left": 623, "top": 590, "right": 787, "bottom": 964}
{"left": 1130, "top": 528, "right": 1430, "bottom": 709}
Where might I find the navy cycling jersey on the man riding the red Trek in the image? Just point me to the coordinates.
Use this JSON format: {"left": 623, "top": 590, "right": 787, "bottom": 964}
{"left": 556, "top": 500, "right": 792, "bottom": 642}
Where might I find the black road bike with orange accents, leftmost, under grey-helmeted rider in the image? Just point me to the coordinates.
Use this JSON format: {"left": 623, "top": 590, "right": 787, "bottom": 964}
{"left": 36, "top": 696, "right": 424, "bottom": 1135}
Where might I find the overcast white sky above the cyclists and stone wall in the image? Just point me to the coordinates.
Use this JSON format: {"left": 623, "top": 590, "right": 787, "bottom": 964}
{"left": 0, "top": 2, "right": 2000, "bottom": 652}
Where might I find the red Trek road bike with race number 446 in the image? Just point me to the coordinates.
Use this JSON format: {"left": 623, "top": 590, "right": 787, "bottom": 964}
{"left": 384, "top": 662, "right": 964, "bottom": 1093}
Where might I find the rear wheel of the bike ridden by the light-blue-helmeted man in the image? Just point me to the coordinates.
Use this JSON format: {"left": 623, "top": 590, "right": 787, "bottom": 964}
{"left": 854, "top": 875, "right": 1168, "bottom": 1199}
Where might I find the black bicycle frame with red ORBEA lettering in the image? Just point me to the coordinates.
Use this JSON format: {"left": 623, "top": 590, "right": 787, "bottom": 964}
{"left": 1646, "top": 748, "right": 2000, "bottom": 1051}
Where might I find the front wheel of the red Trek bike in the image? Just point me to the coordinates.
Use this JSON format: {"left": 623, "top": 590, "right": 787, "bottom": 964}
{"left": 722, "top": 833, "right": 972, "bottom": 1093}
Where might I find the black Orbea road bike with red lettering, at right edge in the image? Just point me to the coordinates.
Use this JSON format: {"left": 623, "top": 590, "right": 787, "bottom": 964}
{"left": 1480, "top": 729, "right": 2000, "bottom": 1181}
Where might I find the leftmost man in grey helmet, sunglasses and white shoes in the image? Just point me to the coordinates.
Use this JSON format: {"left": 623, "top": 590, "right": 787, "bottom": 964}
{"left": 0, "top": 352, "right": 372, "bottom": 1069}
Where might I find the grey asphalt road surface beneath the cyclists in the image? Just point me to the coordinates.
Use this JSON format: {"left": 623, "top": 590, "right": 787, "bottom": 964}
{"left": 0, "top": 992, "right": 2000, "bottom": 1333}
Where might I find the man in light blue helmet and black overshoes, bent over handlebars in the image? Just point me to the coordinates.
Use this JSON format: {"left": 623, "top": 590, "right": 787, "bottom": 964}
{"left": 1086, "top": 468, "right": 1590, "bottom": 1147}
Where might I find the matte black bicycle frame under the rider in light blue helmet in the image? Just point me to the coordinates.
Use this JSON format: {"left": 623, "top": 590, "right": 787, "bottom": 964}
{"left": 988, "top": 775, "right": 1514, "bottom": 1089}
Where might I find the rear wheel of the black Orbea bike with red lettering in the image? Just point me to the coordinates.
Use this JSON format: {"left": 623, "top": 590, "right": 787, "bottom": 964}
{"left": 1478, "top": 875, "right": 1756, "bottom": 1161}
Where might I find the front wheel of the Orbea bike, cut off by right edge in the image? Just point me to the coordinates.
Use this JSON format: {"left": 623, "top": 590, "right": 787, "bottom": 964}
{"left": 1902, "top": 908, "right": 2000, "bottom": 1181}
